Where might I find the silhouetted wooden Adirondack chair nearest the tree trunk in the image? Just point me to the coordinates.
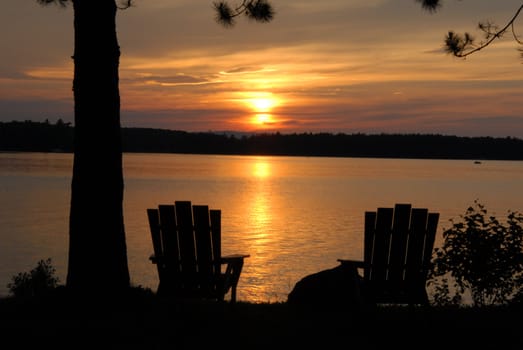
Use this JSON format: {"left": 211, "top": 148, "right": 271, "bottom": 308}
{"left": 147, "top": 201, "right": 249, "bottom": 303}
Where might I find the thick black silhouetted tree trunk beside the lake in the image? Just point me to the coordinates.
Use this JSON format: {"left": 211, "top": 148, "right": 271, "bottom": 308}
{"left": 66, "top": 0, "right": 130, "bottom": 293}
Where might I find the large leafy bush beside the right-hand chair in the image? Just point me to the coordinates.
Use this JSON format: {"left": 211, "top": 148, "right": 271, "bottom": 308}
{"left": 428, "top": 200, "right": 523, "bottom": 306}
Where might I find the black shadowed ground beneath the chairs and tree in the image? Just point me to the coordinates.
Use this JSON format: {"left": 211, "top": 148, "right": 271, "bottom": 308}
{"left": 0, "top": 293, "right": 523, "bottom": 350}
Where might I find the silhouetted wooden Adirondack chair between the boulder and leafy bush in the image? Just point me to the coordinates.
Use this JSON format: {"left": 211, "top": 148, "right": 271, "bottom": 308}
{"left": 338, "top": 204, "right": 439, "bottom": 305}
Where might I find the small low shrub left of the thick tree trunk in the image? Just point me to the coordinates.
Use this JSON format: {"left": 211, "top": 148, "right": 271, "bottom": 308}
{"left": 7, "top": 258, "right": 59, "bottom": 297}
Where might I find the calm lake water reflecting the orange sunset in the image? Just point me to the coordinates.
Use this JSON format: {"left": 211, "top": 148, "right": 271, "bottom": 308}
{"left": 0, "top": 153, "right": 523, "bottom": 302}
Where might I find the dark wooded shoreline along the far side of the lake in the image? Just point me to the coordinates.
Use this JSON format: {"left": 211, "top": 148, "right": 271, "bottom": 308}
{"left": 0, "top": 119, "right": 523, "bottom": 160}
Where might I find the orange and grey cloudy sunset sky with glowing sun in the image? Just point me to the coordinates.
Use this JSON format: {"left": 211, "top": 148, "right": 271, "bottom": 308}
{"left": 0, "top": 0, "right": 523, "bottom": 138}
